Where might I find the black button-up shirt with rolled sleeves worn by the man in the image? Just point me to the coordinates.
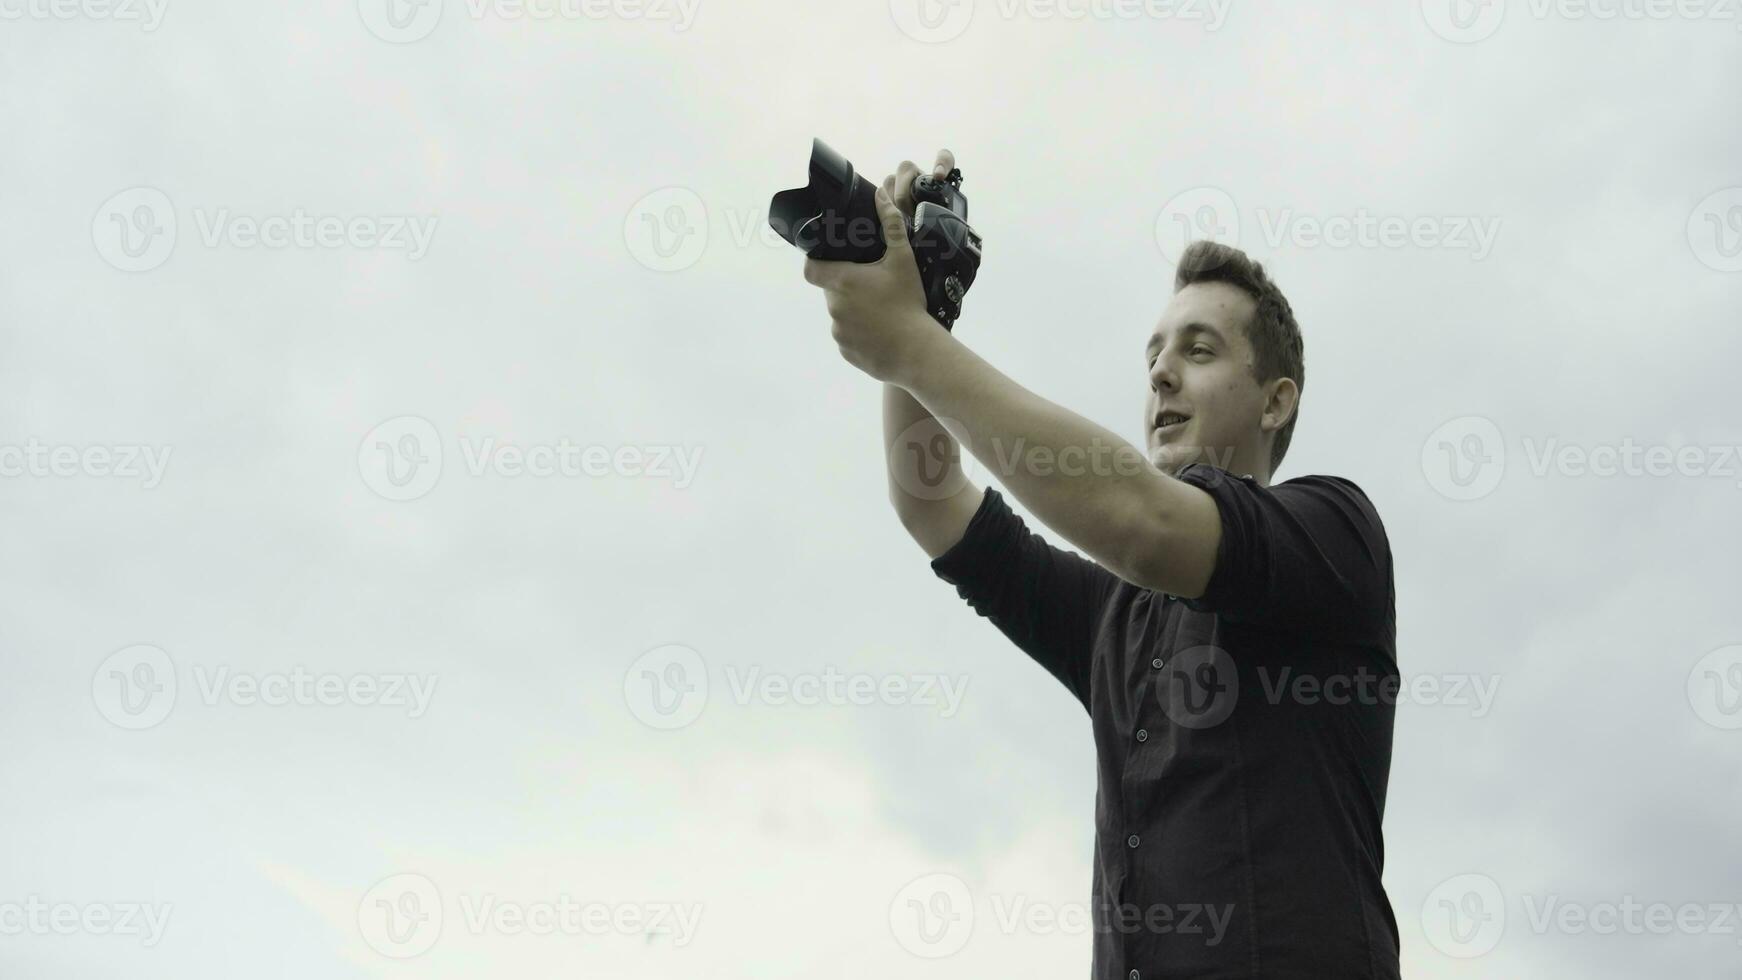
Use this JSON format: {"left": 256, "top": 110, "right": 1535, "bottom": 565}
{"left": 932, "top": 463, "right": 1399, "bottom": 980}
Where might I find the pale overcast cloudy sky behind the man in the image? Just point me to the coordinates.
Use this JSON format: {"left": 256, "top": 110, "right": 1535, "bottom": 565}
{"left": 0, "top": 0, "right": 1742, "bottom": 980}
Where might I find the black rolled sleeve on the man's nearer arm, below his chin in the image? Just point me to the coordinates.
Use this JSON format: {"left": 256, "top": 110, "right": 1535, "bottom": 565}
{"left": 1179, "top": 463, "right": 1395, "bottom": 634}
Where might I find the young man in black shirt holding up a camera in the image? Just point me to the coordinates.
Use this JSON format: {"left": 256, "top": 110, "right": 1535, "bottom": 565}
{"left": 805, "top": 151, "right": 1399, "bottom": 980}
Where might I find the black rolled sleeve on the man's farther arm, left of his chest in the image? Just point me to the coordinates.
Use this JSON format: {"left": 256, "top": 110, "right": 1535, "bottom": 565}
{"left": 932, "top": 487, "right": 1118, "bottom": 708}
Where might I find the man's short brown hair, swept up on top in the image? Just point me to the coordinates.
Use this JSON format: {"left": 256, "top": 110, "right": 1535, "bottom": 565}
{"left": 1174, "top": 240, "right": 1307, "bottom": 473}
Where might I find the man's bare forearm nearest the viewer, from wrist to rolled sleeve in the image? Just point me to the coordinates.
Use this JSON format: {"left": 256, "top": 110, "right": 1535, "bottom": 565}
{"left": 892, "top": 318, "right": 1172, "bottom": 581}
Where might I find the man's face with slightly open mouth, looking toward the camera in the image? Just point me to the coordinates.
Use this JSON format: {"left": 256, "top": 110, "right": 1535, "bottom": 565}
{"left": 1143, "top": 282, "right": 1268, "bottom": 473}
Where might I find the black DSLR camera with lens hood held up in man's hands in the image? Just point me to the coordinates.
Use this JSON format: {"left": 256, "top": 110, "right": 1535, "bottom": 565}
{"left": 768, "top": 139, "right": 981, "bottom": 331}
